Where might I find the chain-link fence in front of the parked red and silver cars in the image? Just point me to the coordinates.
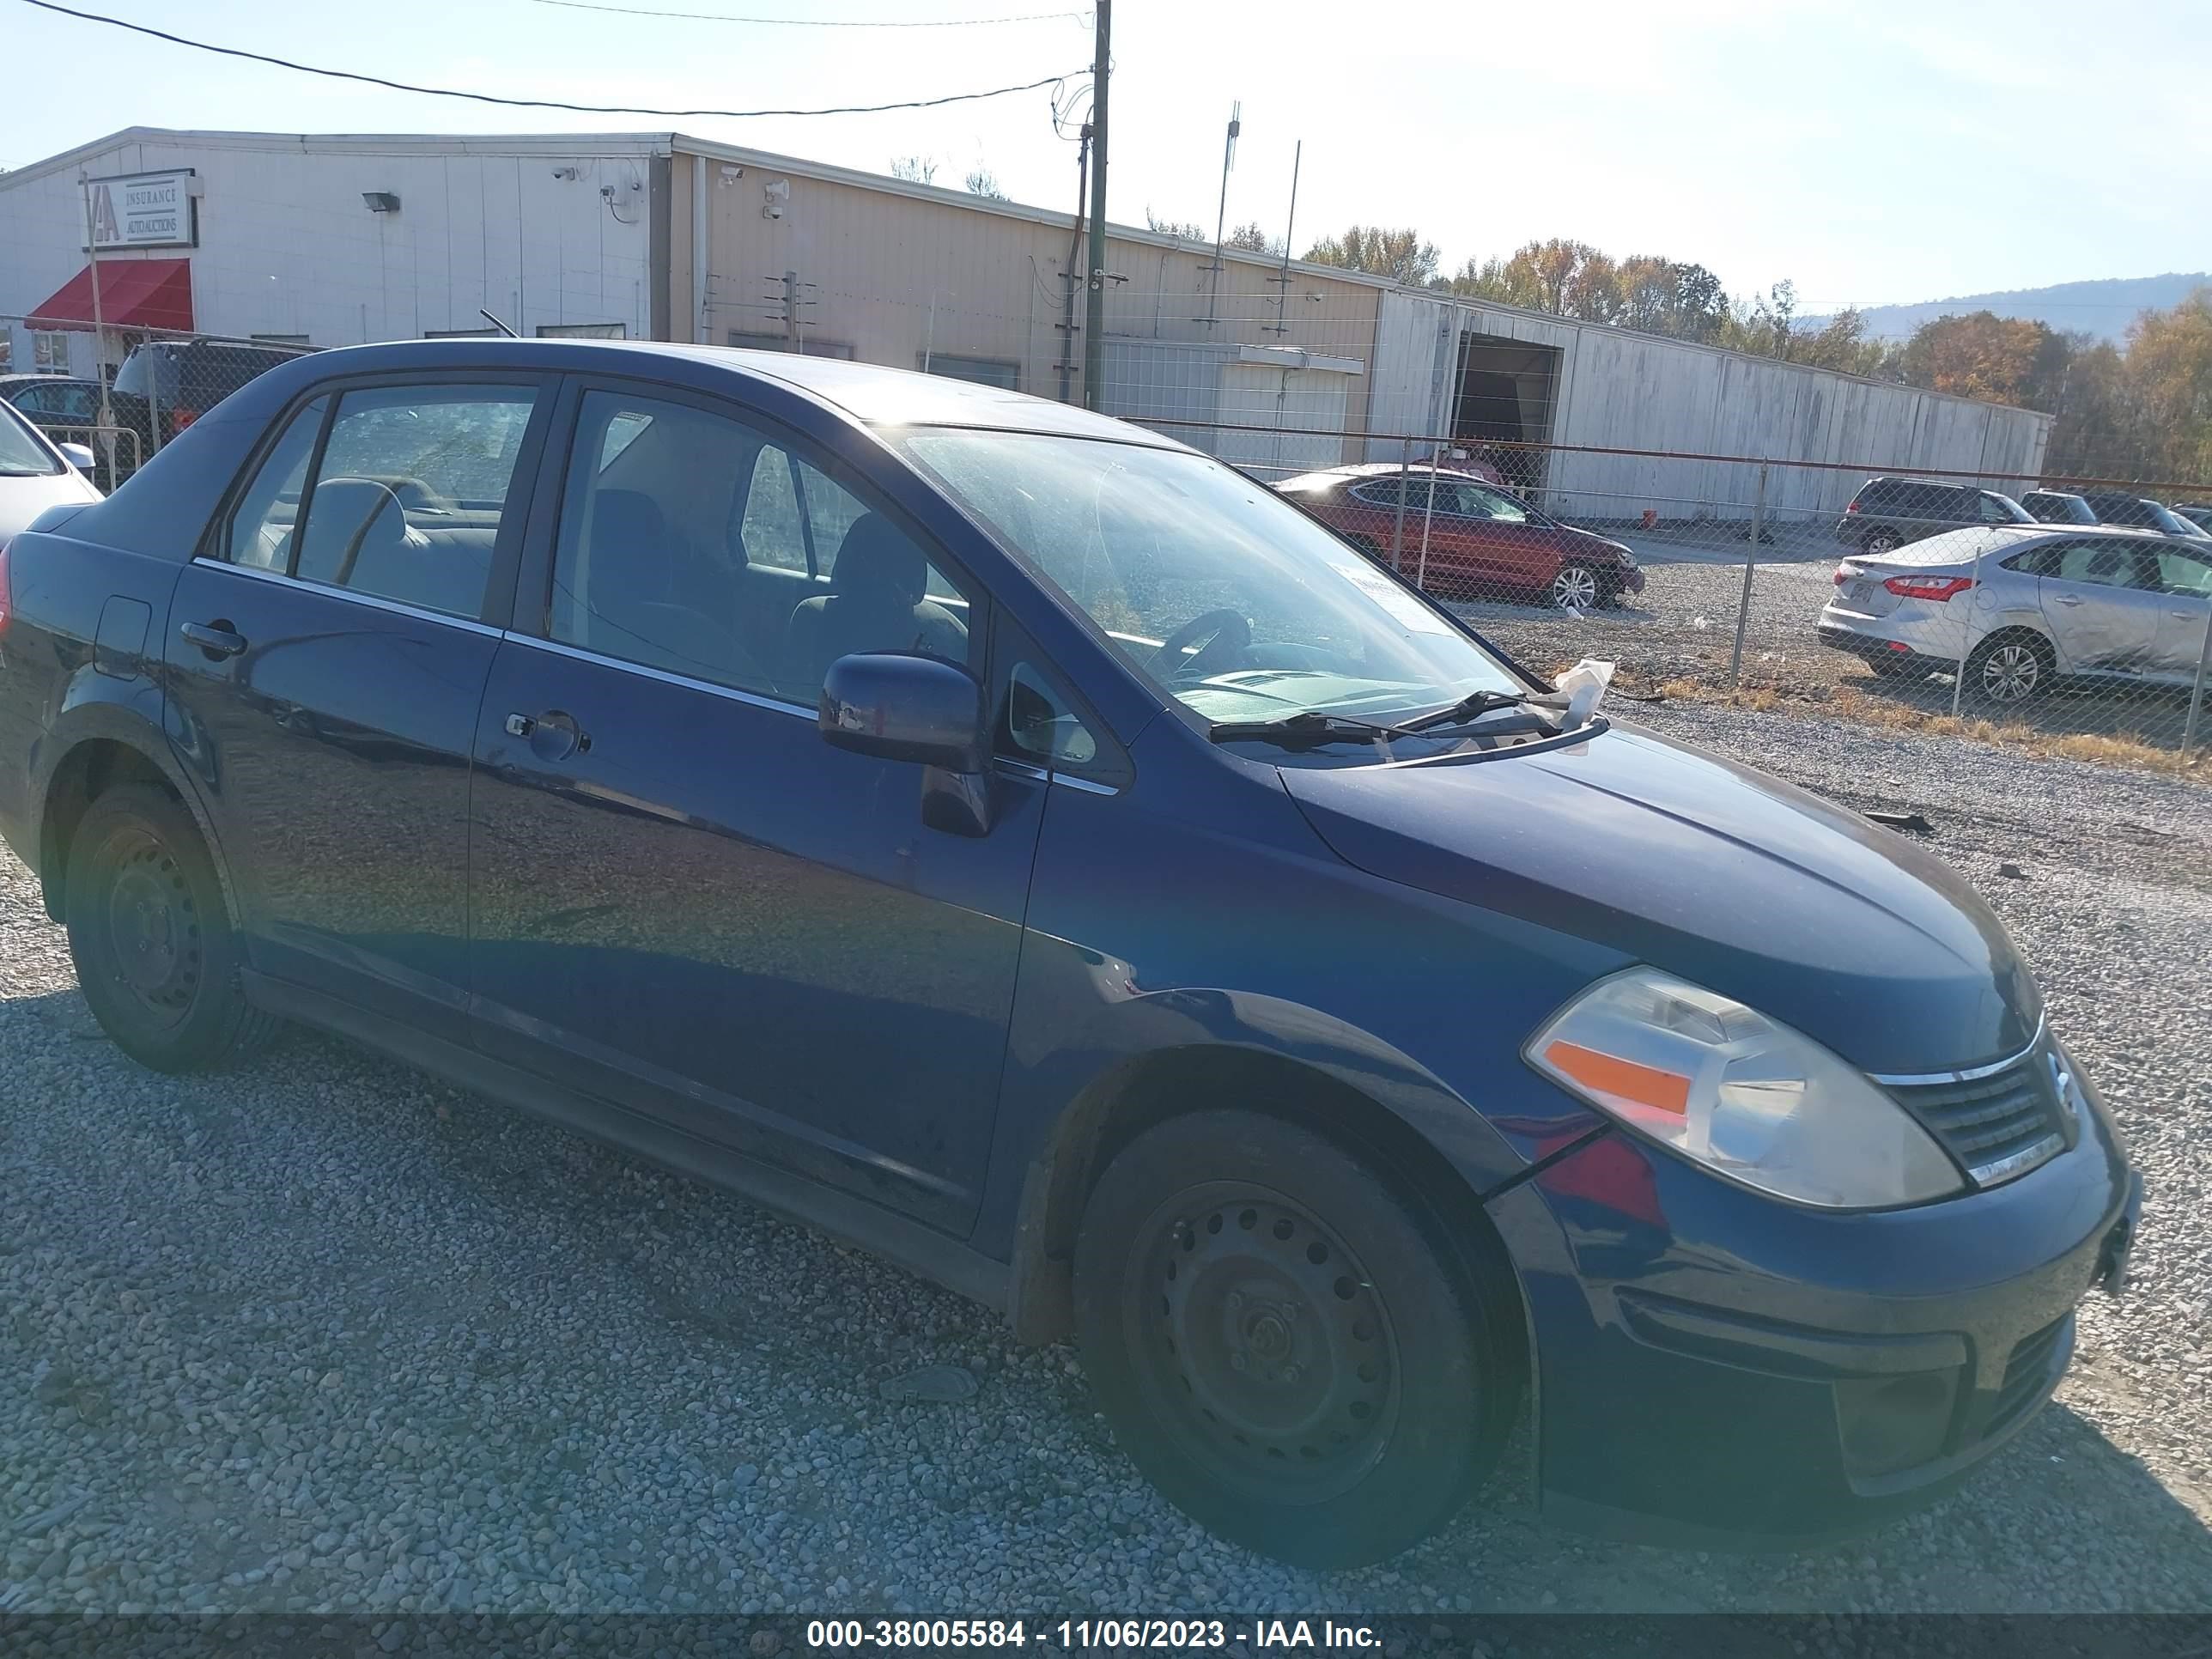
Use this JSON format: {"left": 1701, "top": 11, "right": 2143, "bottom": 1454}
{"left": 1139, "top": 416, "right": 2212, "bottom": 765}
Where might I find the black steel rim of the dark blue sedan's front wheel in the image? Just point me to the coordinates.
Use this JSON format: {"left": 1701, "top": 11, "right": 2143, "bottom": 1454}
{"left": 1128, "top": 1182, "right": 1402, "bottom": 1504}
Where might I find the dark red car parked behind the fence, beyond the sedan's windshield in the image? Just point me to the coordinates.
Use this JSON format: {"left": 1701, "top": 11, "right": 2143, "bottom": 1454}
{"left": 1276, "top": 460, "right": 1644, "bottom": 611}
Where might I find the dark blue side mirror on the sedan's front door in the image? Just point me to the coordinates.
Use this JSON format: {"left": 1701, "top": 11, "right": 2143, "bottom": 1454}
{"left": 814, "top": 650, "right": 991, "bottom": 836}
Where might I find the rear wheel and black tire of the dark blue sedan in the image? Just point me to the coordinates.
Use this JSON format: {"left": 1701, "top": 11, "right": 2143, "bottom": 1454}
{"left": 64, "top": 783, "right": 281, "bottom": 1073}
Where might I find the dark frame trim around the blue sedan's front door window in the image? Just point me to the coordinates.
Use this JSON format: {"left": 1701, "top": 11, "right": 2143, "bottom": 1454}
{"left": 507, "top": 372, "right": 1000, "bottom": 719}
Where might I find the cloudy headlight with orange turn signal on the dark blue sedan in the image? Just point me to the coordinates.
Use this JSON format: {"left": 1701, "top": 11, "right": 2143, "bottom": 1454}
{"left": 1526, "top": 969, "right": 1964, "bottom": 1210}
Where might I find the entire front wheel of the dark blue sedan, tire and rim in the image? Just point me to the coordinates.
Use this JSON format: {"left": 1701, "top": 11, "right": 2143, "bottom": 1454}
{"left": 1075, "top": 1110, "right": 1520, "bottom": 1568}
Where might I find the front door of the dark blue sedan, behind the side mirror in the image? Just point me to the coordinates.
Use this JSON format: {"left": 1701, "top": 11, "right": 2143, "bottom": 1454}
{"left": 469, "top": 380, "right": 1044, "bottom": 1232}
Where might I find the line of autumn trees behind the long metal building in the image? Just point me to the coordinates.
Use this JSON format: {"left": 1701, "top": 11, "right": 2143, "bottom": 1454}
{"left": 1291, "top": 223, "right": 2212, "bottom": 483}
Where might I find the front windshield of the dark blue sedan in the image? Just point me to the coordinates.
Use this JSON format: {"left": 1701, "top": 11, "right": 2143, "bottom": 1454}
{"left": 894, "top": 427, "right": 1528, "bottom": 723}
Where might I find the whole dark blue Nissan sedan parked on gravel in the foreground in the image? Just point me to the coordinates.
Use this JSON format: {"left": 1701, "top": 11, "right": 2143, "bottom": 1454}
{"left": 0, "top": 341, "right": 2139, "bottom": 1566}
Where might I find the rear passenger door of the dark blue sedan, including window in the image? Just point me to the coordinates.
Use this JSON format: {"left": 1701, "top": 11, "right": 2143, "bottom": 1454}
{"left": 166, "top": 374, "right": 550, "bottom": 1040}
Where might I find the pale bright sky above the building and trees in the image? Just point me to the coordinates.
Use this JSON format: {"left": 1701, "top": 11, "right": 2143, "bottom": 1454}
{"left": 0, "top": 0, "right": 2212, "bottom": 314}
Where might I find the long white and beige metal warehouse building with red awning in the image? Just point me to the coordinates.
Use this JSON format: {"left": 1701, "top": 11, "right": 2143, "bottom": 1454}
{"left": 0, "top": 128, "right": 2051, "bottom": 518}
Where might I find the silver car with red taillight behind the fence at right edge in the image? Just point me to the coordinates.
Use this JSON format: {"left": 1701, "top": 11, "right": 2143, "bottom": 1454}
{"left": 1820, "top": 525, "right": 2212, "bottom": 703}
